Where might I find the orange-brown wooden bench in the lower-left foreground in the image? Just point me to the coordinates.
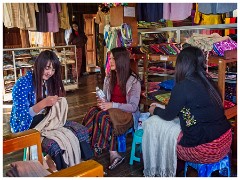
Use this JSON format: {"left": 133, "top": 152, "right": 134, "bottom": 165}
{"left": 3, "top": 129, "right": 103, "bottom": 177}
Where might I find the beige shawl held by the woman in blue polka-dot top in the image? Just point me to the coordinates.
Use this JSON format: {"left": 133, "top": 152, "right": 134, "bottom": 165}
{"left": 35, "top": 97, "right": 81, "bottom": 167}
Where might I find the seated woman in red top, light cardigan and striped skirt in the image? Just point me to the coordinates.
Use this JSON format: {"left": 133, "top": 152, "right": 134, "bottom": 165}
{"left": 83, "top": 47, "right": 141, "bottom": 169}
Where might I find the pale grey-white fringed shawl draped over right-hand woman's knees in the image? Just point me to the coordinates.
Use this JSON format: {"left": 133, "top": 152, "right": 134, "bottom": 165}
{"left": 142, "top": 115, "right": 181, "bottom": 177}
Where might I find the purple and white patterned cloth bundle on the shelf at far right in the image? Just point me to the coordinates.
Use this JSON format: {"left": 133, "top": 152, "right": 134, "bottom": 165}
{"left": 213, "top": 39, "right": 237, "bottom": 56}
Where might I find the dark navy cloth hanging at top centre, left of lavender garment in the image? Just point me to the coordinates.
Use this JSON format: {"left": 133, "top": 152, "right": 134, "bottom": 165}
{"left": 137, "top": 3, "right": 163, "bottom": 22}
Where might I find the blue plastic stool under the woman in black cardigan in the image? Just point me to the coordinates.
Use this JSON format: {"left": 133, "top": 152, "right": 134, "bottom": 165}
{"left": 184, "top": 155, "right": 231, "bottom": 177}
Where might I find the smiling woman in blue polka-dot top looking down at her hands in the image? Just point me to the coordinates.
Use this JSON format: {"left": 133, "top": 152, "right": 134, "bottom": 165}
{"left": 10, "top": 50, "right": 90, "bottom": 170}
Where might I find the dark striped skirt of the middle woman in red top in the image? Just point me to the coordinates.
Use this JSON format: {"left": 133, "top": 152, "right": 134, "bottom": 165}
{"left": 82, "top": 106, "right": 116, "bottom": 151}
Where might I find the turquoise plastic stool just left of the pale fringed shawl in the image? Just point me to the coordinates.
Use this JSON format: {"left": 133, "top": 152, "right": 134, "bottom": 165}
{"left": 129, "top": 129, "right": 143, "bottom": 165}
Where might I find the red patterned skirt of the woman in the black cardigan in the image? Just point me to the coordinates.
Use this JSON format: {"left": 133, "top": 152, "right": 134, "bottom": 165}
{"left": 177, "top": 129, "right": 232, "bottom": 164}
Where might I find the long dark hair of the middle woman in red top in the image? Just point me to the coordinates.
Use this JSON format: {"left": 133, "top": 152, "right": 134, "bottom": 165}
{"left": 110, "top": 47, "right": 137, "bottom": 96}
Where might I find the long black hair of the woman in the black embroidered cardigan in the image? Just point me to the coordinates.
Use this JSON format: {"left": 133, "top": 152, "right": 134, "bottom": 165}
{"left": 175, "top": 47, "right": 222, "bottom": 107}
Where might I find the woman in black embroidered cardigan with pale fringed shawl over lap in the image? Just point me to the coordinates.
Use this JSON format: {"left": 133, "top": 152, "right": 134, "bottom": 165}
{"left": 142, "top": 47, "right": 232, "bottom": 176}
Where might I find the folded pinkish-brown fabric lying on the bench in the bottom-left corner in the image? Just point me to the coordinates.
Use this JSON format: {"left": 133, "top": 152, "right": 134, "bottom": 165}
{"left": 6, "top": 161, "right": 51, "bottom": 177}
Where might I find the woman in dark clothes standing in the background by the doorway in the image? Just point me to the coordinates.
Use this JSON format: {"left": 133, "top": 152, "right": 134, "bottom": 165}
{"left": 68, "top": 21, "right": 87, "bottom": 79}
